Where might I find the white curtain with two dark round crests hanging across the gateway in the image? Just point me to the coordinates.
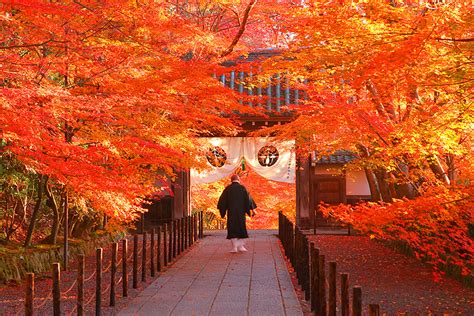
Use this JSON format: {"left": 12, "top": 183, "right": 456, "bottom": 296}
{"left": 191, "top": 137, "right": 296, "bottom": 184}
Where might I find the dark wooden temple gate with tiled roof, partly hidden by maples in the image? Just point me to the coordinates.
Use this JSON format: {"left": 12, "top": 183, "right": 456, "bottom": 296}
{"left": 145, "top": 50, "right": 370, "bottom": 228}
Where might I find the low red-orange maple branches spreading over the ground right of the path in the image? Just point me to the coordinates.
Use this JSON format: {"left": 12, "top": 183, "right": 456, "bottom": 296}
{"left": 321, "top": 186, "right": 474, "bottom": 275}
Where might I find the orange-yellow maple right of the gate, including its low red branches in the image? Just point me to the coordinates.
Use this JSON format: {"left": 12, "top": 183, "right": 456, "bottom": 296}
{"left": 256, "top": 1, "right": 473, "bottom": 274}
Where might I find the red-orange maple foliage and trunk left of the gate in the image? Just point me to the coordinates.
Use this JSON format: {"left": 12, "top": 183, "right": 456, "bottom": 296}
{"left": 0, "top": 1, "right": 282, "bottom": 242}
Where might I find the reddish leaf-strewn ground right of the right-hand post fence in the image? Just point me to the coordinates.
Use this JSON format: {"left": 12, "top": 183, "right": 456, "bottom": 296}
{"left": 289, "top": 235, "right": 474, "bottom": 316}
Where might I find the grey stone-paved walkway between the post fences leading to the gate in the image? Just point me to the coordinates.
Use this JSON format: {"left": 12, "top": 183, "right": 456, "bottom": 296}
{"left": 118, "top": 230, "right": 303, "bottom": 316}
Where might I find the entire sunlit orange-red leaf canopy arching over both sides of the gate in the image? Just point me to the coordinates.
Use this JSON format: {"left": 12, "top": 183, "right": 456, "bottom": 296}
{"left": 0, "top": 0, "right": 474, "bottom": 230}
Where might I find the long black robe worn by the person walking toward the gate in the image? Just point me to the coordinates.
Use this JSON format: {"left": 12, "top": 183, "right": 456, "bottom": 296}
{"left": 217, "top": 182, "right": 257, "bottom": 239}
